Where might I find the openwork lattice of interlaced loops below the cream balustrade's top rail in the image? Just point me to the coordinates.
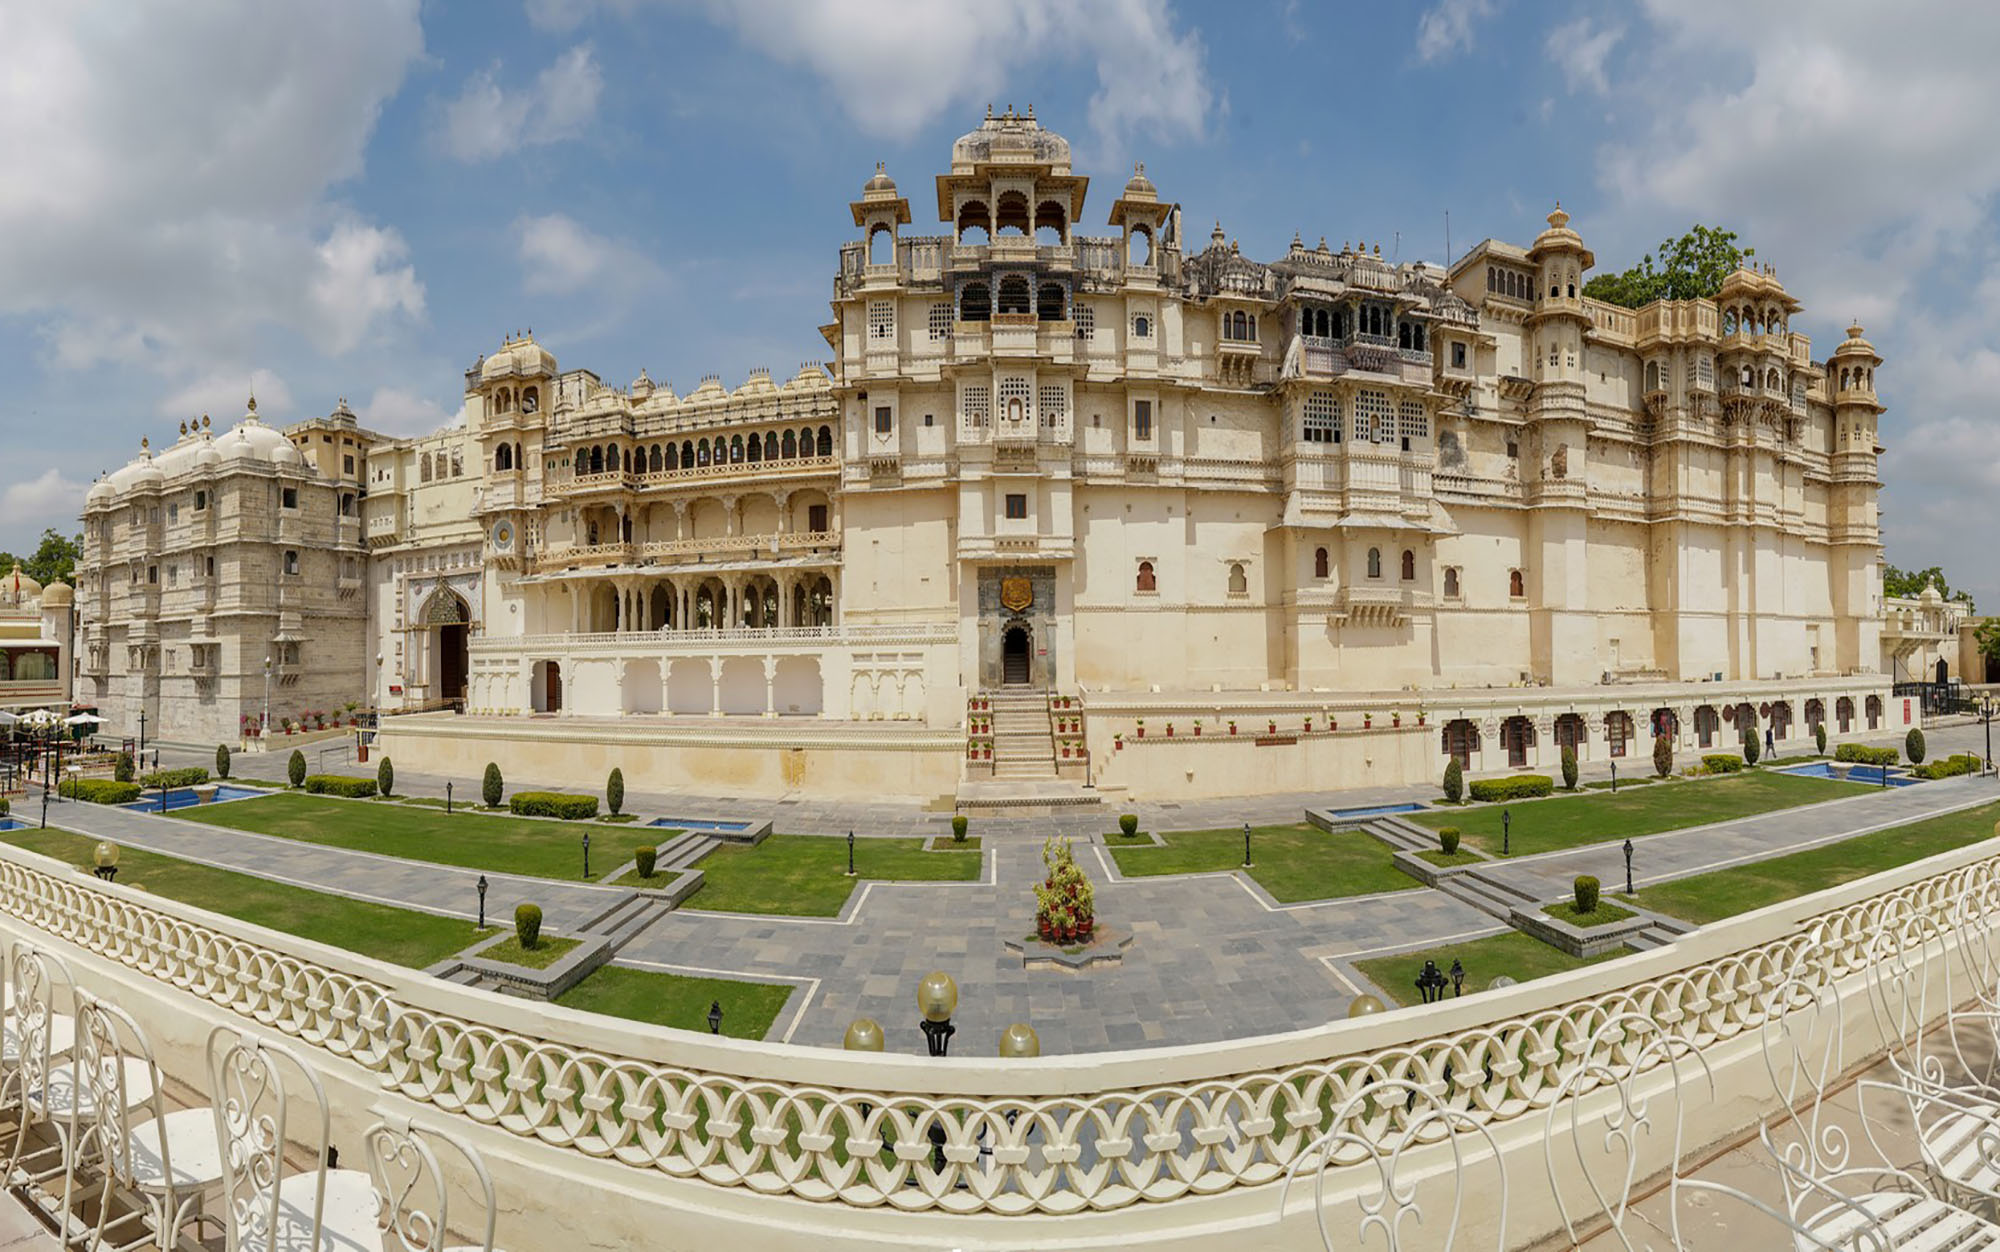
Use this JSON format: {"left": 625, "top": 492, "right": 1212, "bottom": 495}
{"left": 0, "top": 840, "right": 2000, "bottom": 1216}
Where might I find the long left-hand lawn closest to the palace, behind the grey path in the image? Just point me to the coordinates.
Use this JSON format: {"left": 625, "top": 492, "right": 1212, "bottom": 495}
{"left": 174, "top": 792, "right": 670, "bottom": 882}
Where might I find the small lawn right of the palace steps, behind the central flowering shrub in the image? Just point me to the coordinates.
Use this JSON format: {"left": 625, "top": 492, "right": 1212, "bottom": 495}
{"left": 1110, "top": 822, "right": 1422, "bottom": 904}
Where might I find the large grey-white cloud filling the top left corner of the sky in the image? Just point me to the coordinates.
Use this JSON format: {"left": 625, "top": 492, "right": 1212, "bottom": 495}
{"left": 0, "top": 0, "right": 422, "bottom": 376}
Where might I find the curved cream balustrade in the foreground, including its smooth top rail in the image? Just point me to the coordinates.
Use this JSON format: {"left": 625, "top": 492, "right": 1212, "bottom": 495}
{"left": 0, "top": 828, "right": 2000, "bottom": 1218}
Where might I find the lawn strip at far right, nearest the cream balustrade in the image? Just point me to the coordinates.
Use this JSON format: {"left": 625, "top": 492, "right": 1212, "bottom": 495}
{"left": 1618, "top": 804, "right": 2000, "bottom": 922}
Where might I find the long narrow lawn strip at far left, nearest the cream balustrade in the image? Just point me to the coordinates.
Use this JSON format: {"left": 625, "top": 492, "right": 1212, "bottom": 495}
{"left": 0, "top": 828, "right": 492, "bottom": 968}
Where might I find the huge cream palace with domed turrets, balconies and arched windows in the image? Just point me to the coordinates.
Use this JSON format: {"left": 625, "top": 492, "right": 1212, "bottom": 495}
{"left": 76, "top": 108, "right": 1920, "bottom": 796}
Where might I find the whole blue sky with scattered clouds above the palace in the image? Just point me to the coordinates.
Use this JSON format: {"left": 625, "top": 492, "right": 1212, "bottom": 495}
{"left": 0, "top": 0, "right": 2000, "bottom": 610}
